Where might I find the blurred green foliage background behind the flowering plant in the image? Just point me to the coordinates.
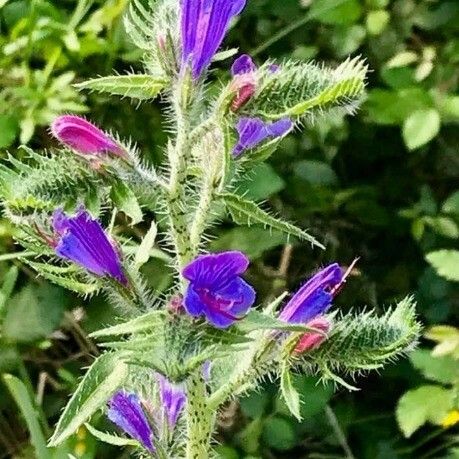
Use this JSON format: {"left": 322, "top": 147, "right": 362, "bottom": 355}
{"left": 0, "top": 0, "right": 459, "bottom": 459}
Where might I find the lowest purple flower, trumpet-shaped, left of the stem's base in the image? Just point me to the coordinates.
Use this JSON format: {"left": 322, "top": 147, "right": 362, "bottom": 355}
{"left": 107, "top": 391, "right": 155, "bottom": 452}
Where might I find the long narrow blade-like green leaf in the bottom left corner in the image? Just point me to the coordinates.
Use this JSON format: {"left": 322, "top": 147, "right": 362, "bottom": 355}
{"left": 3, "top": 375, "right": 52, "bottom": 459}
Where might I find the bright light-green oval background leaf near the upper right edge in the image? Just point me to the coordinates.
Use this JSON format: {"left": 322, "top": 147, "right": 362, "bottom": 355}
{"left": 403, "top": 109, "right": 441, "bottom": 150}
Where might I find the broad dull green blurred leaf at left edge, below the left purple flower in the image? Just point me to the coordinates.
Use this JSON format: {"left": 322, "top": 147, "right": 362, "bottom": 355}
{"left": 3, "top": 284, "right": 68, "bottom": 343}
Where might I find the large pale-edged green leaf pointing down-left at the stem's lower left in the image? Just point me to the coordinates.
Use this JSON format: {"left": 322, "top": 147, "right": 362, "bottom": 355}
{"left": 49, "top": 353, "right": 129, "bottom": 446}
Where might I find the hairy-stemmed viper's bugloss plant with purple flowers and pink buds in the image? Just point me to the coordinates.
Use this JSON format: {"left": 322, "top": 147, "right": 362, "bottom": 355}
{"left": 0, "top": 0, "right": 419, "bottom": 459}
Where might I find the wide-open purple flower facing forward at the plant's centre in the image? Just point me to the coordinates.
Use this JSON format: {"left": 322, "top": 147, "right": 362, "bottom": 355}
{"left": 182, "top": 251, "right": 255, "bottom": 328}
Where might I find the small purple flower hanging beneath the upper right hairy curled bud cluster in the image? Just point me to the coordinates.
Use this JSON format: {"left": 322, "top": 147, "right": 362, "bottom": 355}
{"left": 233, "top": 118, "right": 293, "bottom": 156}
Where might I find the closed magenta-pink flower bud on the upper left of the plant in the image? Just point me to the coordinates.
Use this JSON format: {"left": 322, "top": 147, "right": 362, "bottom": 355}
{"left": 51, "top": 115, "right": 125, "bottom": 156}
